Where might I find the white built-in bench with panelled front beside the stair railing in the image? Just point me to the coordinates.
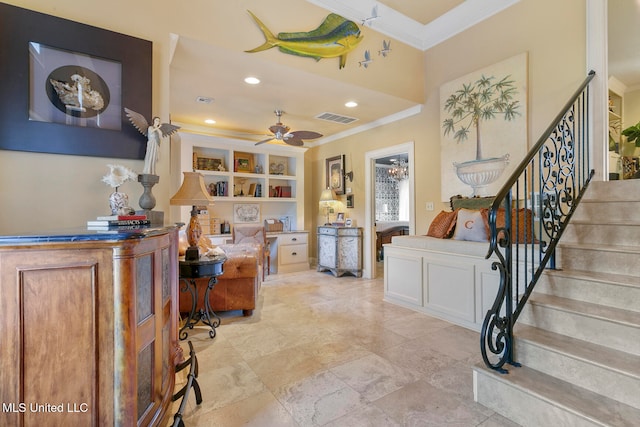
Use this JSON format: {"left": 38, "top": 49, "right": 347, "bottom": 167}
{"left": 384, "top": 236, "right": 508, "bottom": 331}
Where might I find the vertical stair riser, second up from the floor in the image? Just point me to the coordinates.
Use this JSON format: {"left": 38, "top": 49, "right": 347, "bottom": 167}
{"left": 515, "top": 336, "right": 640, "bottom": 409}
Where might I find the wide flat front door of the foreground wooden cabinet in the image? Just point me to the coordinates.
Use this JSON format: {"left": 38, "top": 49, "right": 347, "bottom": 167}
{"left": 0, "top": 249, "right": 115, "bottom": 426}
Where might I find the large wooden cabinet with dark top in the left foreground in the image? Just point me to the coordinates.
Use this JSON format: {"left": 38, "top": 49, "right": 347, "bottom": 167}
{"left": 0, "top": 227, "right": 181, "bottom": 426}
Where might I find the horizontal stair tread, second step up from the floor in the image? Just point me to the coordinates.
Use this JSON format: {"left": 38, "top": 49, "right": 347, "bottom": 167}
{"left": 515, "top": 324, "right": 640, "bottom": 380}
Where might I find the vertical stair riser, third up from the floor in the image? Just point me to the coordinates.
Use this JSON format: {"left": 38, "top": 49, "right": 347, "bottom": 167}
{"left": 518, "top": 301, "right": 640, "bottom": 356}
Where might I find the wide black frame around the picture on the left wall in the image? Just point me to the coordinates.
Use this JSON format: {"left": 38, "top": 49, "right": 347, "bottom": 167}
{"left": 0, "top": 3, "right": 152, "bottom": 159}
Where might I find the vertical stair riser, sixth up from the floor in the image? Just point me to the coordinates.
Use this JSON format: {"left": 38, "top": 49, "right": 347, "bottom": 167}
{"left": 562, "top": 223, "right": 640, "bottom": 246}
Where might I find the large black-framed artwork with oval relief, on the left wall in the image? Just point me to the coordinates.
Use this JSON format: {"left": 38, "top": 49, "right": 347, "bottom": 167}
{"left": 0, "top": 3, "right": 152, "bottom": 159}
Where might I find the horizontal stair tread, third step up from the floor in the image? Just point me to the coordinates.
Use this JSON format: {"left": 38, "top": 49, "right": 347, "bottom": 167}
{"left": 529, "top": 293, "right": 640, "bottom": 328}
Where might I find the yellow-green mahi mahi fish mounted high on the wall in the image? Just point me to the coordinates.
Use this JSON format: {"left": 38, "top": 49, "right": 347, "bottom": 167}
{"left": 245, "top": 10, "right": 363, "bottom": 68}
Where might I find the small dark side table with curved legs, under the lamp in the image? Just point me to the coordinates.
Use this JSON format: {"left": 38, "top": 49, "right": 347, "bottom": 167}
{"left": 178, "top": 256, "right": 227, "bottom": 340}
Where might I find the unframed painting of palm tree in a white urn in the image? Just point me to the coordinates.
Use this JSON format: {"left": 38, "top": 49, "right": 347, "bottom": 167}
{"left": 440, "top": 53, "right": 527, "bottom": 201}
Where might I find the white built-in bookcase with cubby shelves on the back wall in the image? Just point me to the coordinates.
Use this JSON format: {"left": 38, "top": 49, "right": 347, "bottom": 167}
{"left": 172, "top": 132, "right": 306, "bottom": 234}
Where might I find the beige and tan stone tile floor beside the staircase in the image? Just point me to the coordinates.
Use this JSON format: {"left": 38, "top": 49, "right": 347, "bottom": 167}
{"left": 168, "top": 270, "right": 516, "bottom": 427}
